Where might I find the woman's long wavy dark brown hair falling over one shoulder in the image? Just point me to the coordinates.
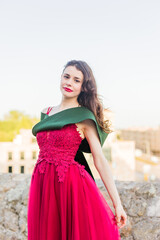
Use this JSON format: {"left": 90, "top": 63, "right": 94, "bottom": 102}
{"left": 63, "top": 60, "right": 113, "bottom": 133}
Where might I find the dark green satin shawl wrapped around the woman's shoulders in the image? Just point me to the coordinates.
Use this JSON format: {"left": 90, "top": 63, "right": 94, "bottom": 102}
{"left": 32, "top": 106, "right": 108, "bottom": 179}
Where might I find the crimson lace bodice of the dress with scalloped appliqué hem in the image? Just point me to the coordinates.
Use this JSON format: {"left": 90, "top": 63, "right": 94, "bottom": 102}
{"left": 33, "top": 123, "right": 85, "bottom": 182}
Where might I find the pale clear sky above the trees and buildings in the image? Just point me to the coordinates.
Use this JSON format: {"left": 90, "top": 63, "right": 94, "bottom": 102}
{"left": 0, "top": 0, "right": 160, "bottom": 128}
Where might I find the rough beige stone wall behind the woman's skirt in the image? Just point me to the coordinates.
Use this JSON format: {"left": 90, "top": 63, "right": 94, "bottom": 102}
{"left": 0, "top": 173, "right": 160, "bottom": 240}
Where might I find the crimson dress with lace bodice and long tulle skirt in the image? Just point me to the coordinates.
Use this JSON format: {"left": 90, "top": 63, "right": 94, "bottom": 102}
{"left": 27, "top": 108, "right": 120, "bottom": 240}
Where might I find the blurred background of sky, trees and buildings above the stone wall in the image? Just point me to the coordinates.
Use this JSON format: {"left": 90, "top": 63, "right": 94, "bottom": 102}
{"left": 0, "top": 0, "right": 160, "bottom": 181}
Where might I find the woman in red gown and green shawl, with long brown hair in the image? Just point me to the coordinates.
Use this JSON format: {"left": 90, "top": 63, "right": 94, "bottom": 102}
{"left": 28, "top": 60, "right": 127, "bottom": 240}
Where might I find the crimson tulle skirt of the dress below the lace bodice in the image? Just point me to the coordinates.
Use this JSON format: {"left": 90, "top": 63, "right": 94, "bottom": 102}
{"left": 27, "top": 162, "right": 120, "bottom": 240}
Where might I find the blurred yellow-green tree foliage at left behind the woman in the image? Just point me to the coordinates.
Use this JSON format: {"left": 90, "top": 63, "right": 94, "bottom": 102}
{"left": 0, "top": 110, "right": 39, "bottom": 142}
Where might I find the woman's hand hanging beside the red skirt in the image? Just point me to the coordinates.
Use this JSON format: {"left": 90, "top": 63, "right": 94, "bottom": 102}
{"left": 115, "top": 204, "right": 127, "bottom": 228}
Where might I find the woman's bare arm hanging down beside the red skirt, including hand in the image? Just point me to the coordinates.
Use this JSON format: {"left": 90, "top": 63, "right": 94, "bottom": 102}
{"left": 83, "top": 119, "right": 126, "bottom": 226}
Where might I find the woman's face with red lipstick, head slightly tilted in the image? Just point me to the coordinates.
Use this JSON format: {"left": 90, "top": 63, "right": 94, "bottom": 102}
{"left": 60, "top": 66, "right": 83, "bottom": 97}
